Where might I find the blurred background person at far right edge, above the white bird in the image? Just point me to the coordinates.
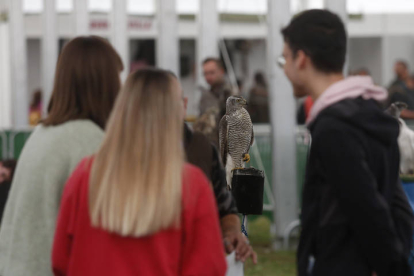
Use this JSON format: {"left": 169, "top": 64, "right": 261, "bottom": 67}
{"left": 388, "top": 61, "right": 414, "bottom": 120}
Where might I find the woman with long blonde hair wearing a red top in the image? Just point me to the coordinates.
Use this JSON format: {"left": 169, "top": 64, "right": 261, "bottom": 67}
{"left": 52, "top": 69, "right": 226, "bottom": 276}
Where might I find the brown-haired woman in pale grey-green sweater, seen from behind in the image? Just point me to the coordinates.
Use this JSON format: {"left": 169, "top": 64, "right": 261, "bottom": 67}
{"left": 0, "top": 36, "right": 123, "bottom": 276}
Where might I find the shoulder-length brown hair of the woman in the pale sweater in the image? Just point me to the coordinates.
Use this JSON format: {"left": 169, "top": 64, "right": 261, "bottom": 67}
{"left": 42, "top": 36, "right": 123, "bottom": 129}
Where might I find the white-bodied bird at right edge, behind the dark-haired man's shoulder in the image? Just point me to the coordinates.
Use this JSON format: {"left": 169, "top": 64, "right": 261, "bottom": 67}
{"left": 386, "top": 102, "right": 414, "bottom": 174}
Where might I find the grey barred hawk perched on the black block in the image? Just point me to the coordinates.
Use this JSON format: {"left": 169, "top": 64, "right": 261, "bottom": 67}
{"left": 219, "top": 96, "right": 254, "bottom": 189}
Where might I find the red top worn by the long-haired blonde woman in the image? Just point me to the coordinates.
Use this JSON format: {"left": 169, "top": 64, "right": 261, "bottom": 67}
{"left": 52, "top": 160, "right": 226, "bottom": 276}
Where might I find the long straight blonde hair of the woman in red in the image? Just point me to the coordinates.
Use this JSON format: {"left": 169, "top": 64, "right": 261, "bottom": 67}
{"left": 89, "top": 69, "right": 184, "bottom": 237}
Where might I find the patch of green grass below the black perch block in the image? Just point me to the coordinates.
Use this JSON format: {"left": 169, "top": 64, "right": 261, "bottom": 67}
{"left": 245, "top": 217, "right": 296, "bottom": 276}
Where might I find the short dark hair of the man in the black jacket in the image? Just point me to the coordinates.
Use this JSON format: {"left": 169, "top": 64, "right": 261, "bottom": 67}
{"left": 282, "top": 10, "right": 347, "bottom": 73}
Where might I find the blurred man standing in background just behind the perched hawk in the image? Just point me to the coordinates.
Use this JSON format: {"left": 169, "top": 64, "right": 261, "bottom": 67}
{"left": 193, "top": 58, "right": 232, "bottom": 147}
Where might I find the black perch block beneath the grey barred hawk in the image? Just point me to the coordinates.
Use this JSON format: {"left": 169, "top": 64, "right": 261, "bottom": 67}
{"left": 231, "top": 168, "right": 264, "bottom": 215}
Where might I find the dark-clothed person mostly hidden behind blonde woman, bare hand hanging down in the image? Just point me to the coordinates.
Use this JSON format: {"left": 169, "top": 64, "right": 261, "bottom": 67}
{"left": 183, "top": 98, "right": 257, "bottom": 264}
